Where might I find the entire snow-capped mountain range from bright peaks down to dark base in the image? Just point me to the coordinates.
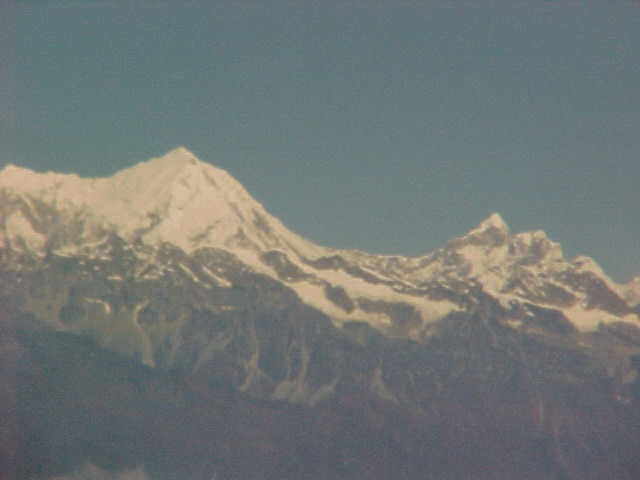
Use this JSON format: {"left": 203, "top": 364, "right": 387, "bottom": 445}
{"left": 0, "top": 147, "right": 640, "bottom": 479}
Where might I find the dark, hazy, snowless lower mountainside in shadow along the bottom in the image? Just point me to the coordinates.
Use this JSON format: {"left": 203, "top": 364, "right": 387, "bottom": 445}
{"left": 3, "top": 300, "right": 640, "bottom": 480}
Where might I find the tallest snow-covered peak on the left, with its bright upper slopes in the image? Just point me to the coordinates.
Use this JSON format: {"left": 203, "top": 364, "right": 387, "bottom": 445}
{"left": 0, "top": 147, "right": 328, "bottom": 253}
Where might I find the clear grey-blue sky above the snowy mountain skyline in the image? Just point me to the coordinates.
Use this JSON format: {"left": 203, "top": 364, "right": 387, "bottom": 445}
{"left": 0, "top": 0, "right": 640, "bottom": 280}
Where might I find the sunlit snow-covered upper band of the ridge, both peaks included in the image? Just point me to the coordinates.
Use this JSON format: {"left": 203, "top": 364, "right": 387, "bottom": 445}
{"left": 0, "top": 147, "right": 636, "bottom": 334}
